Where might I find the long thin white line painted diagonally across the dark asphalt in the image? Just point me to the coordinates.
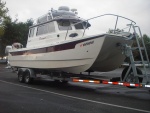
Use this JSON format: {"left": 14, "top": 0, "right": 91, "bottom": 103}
{"left": 0, "top": 80, "right": 150, "bottom": 113}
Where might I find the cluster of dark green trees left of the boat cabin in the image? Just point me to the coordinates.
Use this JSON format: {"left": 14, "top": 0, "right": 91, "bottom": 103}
{"left": 0, "top": 0, "right": 33, "bottom": 57}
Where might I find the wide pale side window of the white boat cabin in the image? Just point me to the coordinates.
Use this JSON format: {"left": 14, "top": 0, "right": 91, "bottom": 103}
{"left": 36, "top": 22, "right": 55, "bottom": 35}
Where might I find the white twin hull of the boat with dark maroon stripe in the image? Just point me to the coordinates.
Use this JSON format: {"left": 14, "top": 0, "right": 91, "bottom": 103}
{"left": 9, "top": 34, "right": 130, "bottom": 73}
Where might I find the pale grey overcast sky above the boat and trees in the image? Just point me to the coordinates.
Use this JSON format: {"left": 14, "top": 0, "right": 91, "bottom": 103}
{"left": 2, "top": 0, "right": 150, "bottom": 36}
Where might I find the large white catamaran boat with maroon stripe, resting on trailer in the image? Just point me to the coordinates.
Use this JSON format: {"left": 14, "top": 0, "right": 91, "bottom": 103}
{"left": 8, "top": 6, "right": 135, "bottom": 74}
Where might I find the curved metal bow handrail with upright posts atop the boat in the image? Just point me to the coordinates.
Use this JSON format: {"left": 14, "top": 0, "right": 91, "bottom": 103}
{"left": 65, "top": 14, "right": 136, "bottom": 40}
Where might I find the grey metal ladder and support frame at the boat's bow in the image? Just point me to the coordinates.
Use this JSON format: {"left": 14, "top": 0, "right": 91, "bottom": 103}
{"left": 121, "top": 24, "right": 150, "bottom": 85}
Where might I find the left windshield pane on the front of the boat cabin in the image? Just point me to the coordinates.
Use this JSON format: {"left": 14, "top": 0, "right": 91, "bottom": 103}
{"left": 57, "top": 20, "right": 72, "bottom": 30}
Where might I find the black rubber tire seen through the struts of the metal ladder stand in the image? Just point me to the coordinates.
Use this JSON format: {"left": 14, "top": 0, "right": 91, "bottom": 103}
{"left": 121, "top": 66, "right": 143, "bottom": 88}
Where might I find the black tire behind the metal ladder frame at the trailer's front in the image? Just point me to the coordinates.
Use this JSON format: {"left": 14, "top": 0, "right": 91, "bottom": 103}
{"left": 121, "top": 67, "right": 143, "bottom": 88}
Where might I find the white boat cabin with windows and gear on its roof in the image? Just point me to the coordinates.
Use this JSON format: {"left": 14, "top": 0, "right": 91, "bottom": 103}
{"left": 27, "top": 6, "right": 90, "bottom": 47}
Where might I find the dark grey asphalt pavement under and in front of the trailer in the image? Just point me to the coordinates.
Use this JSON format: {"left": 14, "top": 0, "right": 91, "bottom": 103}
{"left": 0, "top": 65, "right": 150, "bottom": 113}
